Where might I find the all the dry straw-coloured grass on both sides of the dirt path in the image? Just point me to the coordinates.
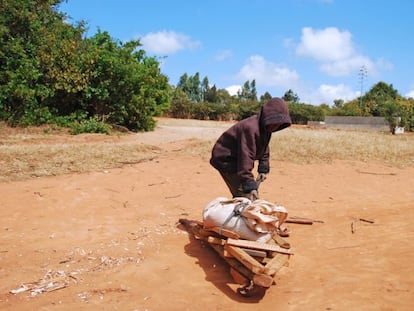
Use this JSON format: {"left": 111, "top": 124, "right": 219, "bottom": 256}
{"left": 0, "top": 119, "right": 414, "bottom": 181}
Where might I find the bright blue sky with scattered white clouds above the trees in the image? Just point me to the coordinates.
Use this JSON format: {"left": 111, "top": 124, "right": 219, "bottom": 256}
{"left": 59, "top": 0, "right": 414, "bottom": 105}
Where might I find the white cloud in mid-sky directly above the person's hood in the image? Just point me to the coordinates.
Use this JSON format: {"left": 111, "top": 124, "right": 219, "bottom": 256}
{"left": 238, "top": 55, "right": 299, "bottom": 88}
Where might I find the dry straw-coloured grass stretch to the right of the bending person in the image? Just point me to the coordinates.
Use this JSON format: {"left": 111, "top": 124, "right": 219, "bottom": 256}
{"left": 271, "top": 128, "right": 414, "bottom": 167}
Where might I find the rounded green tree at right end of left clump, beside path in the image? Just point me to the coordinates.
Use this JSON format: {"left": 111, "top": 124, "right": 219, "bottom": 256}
{"left": 84, "top": 31, "right": 170, "bottom": 131}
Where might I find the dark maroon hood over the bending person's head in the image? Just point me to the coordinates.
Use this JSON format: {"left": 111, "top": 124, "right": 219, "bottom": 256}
{"left": 259, "top": 98, "right": 292, "bottom": 132}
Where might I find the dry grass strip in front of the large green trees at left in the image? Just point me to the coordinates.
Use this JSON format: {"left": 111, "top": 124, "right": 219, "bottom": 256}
{"left": 0, "top": 142, "right": 161, "bottom": 181}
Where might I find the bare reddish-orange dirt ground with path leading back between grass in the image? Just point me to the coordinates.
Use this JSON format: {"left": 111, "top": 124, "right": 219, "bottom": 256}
{"left": 0, "top": 126, "right": 414, "bottom": 311}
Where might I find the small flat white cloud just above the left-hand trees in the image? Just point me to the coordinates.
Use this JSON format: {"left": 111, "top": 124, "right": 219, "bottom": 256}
{"left": 140, "top": 30, "right": 200, "bottom": 55}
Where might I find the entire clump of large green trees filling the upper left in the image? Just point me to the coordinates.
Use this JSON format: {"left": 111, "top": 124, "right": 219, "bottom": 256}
{"left": 0, "top": 0, "right": 170, "bottom": 130}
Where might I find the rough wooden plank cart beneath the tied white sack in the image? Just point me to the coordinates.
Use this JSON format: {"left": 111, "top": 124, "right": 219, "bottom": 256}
{"left": 179, "top": 219, "right": 293, "bottom": 297}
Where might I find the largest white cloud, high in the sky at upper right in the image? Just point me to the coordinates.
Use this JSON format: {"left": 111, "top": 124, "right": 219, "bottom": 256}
{"left": 296, "top": 27, "right": 376, "bottom": 76}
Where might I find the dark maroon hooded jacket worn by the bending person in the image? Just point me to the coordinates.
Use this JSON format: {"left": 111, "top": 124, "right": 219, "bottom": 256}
{"left": 210, "top": 98, "right": 292, "bottom": 193}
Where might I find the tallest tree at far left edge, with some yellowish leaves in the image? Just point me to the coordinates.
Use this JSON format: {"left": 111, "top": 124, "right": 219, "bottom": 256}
{"left": 0, "top": 0, "right": 87, "bottom": 124}
